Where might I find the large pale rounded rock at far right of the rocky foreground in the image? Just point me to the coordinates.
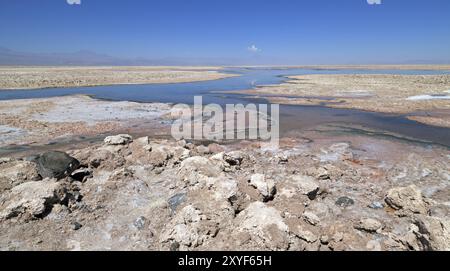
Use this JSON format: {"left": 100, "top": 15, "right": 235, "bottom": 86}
{"left": 385, "top": 185, "right": 427, "bottom": 214}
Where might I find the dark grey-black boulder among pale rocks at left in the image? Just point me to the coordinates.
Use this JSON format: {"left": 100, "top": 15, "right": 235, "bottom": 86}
{"left": 36, "top": 151, "right": 80, "bottom": 179}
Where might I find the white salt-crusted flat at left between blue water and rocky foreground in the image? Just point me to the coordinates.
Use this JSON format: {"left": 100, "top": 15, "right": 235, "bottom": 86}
{"left": 0, "top": 95, "right": 171, "bottom": 147}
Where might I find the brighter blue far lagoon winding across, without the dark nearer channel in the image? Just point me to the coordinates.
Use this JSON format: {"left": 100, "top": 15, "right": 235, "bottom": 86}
{"left": 0, "top": 68, "right": 450, "bottom": 104}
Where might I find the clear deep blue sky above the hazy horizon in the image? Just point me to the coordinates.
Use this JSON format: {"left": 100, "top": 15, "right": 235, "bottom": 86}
{"left": 0, "top": 0, "right": 450, "bottom": 64}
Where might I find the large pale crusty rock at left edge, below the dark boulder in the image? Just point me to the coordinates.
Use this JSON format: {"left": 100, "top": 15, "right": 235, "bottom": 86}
{"left": 0, "top": 179, "right": 66, "bottom": 220}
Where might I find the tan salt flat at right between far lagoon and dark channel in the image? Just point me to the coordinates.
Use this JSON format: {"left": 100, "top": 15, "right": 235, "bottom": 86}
{"left": 239, "top": 74, "right": 450, "bottom": 127}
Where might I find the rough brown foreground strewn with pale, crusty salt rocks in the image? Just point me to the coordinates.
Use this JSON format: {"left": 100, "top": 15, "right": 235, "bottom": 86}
{"left": 0, "top": 134, "right": 450, "bottom": 251}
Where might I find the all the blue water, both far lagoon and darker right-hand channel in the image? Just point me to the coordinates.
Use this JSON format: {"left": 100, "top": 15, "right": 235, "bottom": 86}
{"left": 0, "top": 68, "right": 450, "bottom": 147}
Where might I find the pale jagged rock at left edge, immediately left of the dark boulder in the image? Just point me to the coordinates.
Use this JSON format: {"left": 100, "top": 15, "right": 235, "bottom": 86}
{"left": 0, "top": 159, "right": 41, "bottom": 193}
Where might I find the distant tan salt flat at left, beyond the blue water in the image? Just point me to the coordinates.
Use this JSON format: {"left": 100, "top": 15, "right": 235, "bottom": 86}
{"left": 0, "top": 67, "right": 234, "bottom": 90}
